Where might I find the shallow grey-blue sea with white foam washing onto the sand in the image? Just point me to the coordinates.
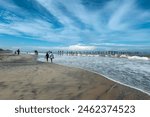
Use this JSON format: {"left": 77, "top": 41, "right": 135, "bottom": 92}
{"left": 38, "top": 53, "right": 150, "bottom": 95}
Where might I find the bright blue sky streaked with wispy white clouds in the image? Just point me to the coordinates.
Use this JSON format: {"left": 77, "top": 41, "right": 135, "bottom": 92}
{"left": 0, "top": 0, "right": 150, "bottom": 51}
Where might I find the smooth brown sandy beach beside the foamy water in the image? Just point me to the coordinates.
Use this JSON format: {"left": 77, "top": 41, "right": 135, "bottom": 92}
{"left": 0, "top": 54, "right": 150, "bottom": 100}
